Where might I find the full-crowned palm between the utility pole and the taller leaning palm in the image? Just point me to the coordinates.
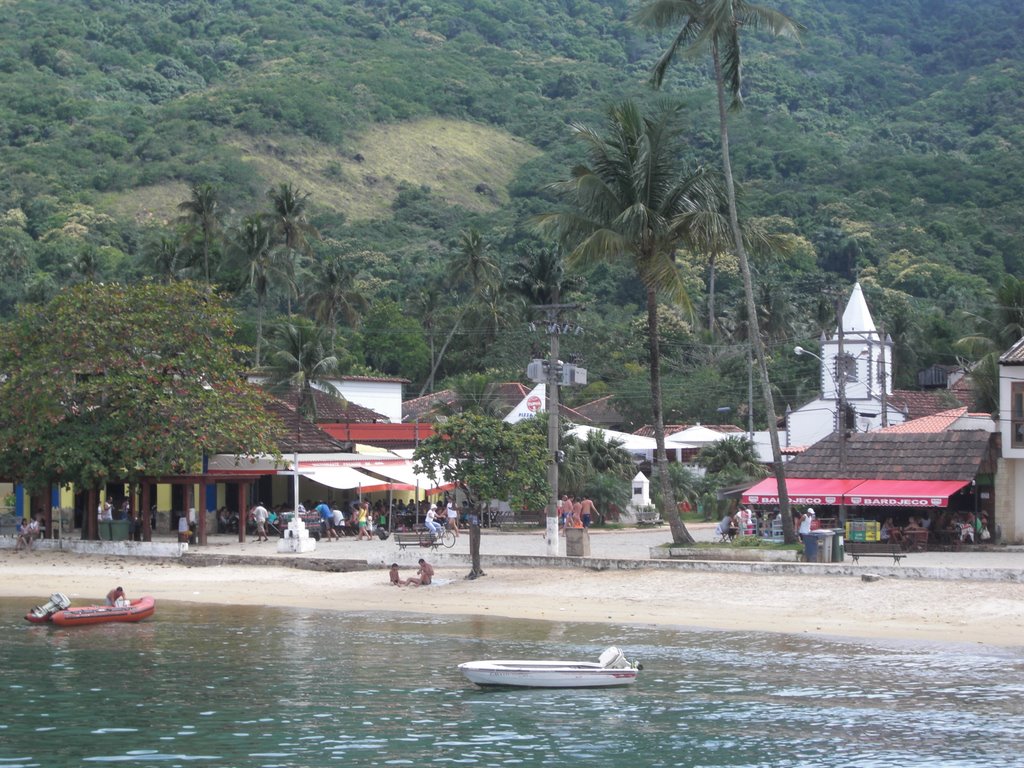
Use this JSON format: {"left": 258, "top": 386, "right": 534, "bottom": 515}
{"left": 539, "top": 101, "right": 719, "bottom": 543}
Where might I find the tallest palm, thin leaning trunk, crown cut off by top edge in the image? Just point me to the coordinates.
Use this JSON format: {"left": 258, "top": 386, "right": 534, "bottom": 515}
{"left": 637, "top": 0, "right": 801, "bottom": 542}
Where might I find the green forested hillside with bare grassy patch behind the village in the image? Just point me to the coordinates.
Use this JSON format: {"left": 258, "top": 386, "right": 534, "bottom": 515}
{"left": 0, "top": 0, "right": 1024, "bottom": 428}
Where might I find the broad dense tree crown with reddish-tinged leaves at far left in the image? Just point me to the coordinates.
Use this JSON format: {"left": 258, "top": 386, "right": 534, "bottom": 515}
{"left": 0, "top": 282, "right": 281, "bottom": 490}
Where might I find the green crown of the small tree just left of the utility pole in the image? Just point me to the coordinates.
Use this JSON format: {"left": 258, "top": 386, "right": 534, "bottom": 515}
{"left": 414, "top": 413, "right": 550, "bottom": 510}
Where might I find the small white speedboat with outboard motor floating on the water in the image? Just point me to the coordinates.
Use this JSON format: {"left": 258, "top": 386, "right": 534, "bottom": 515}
{"left": 459, "top": 647, "right": 642, "bottom": 688}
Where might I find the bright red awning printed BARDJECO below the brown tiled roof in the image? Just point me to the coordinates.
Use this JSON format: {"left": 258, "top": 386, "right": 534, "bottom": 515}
{"left": 741, "top": 477, "right": 969, "bottom": 507}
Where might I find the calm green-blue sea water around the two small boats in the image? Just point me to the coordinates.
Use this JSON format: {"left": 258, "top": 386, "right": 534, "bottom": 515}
{"left": 0, "top": 600, "right": 1024, "bottom": 768}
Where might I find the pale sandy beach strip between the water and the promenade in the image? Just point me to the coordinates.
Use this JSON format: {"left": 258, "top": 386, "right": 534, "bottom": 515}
{"left": 0, "top": 551, "right": 1024, "bottom": 647}
